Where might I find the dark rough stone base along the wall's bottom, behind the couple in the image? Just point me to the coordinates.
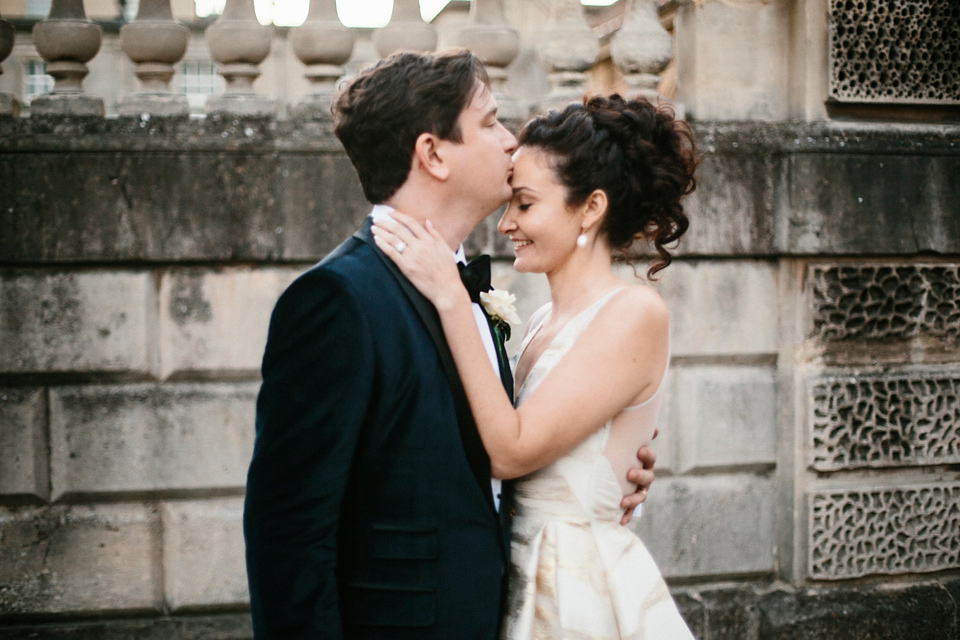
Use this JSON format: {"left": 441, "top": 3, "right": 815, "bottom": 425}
{"left": 0, "top": 576, "right": 960, "bottom": 640}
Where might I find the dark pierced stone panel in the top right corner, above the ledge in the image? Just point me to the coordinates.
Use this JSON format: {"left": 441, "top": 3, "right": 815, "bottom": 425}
{"left": 829, "top": 0, "right": 960, "bottom": 104}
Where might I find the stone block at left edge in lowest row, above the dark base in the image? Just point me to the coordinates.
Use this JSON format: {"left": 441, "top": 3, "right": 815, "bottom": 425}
{"left": 0, "top": 504, "right": 161, "bottom": 617}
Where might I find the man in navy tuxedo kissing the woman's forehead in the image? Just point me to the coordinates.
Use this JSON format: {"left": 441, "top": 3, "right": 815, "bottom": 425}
{"left": 244, "top": 52, "right": 652, "bottom": 640}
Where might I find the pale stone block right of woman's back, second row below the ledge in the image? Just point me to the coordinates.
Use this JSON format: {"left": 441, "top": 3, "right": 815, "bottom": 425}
{"left": 663, "top": 365, "right": 778, "bottom": 473}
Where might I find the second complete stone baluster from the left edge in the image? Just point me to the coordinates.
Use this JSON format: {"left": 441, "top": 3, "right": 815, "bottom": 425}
{"left": 117, "top": 0, "right": 190, "bottom": 116}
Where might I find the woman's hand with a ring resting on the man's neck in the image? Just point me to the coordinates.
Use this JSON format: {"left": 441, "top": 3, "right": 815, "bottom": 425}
{"left": 372, "top": 211, "right": 470, "bottom": 312}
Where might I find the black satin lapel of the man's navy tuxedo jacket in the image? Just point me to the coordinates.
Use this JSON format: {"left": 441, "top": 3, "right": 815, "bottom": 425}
{"left": 354, "top": 218, "right": 497, "bottom": 516}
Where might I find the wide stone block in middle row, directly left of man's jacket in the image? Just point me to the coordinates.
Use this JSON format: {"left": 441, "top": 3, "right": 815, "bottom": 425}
{"left": 50, "top": 383, "right": 257, "bottom": 498}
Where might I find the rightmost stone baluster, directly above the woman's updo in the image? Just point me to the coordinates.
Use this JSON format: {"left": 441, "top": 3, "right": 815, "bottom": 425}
{"left": 611, "top": 0, "right": 673, "bottom": 104}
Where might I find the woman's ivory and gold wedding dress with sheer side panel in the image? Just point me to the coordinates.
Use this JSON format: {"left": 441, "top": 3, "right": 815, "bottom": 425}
{"left": 504, "top": 289, "right": 693, "bottom": 640}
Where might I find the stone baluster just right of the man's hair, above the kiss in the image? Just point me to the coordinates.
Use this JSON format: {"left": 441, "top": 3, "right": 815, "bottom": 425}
{"left": 458, "top": 0, "right": 527, "bottom": 124}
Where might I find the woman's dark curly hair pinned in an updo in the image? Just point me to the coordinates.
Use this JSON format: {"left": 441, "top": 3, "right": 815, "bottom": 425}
{"left": 519, "top": 94, "right": 697, "bottom": 277}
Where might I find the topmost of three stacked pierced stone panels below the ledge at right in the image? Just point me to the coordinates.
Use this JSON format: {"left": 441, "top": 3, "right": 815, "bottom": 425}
{"left": 810, "top": 264, "right": 960, "bottom": 341}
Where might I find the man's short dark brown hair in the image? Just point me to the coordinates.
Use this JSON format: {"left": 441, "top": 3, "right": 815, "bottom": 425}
{"left": 331, "top": 50, "right": 490, "bottom": 204}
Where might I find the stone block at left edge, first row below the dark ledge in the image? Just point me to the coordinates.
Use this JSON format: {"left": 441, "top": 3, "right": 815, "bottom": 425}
{"left": 0, "top": 271, "right": 156, "bottom": 373}
